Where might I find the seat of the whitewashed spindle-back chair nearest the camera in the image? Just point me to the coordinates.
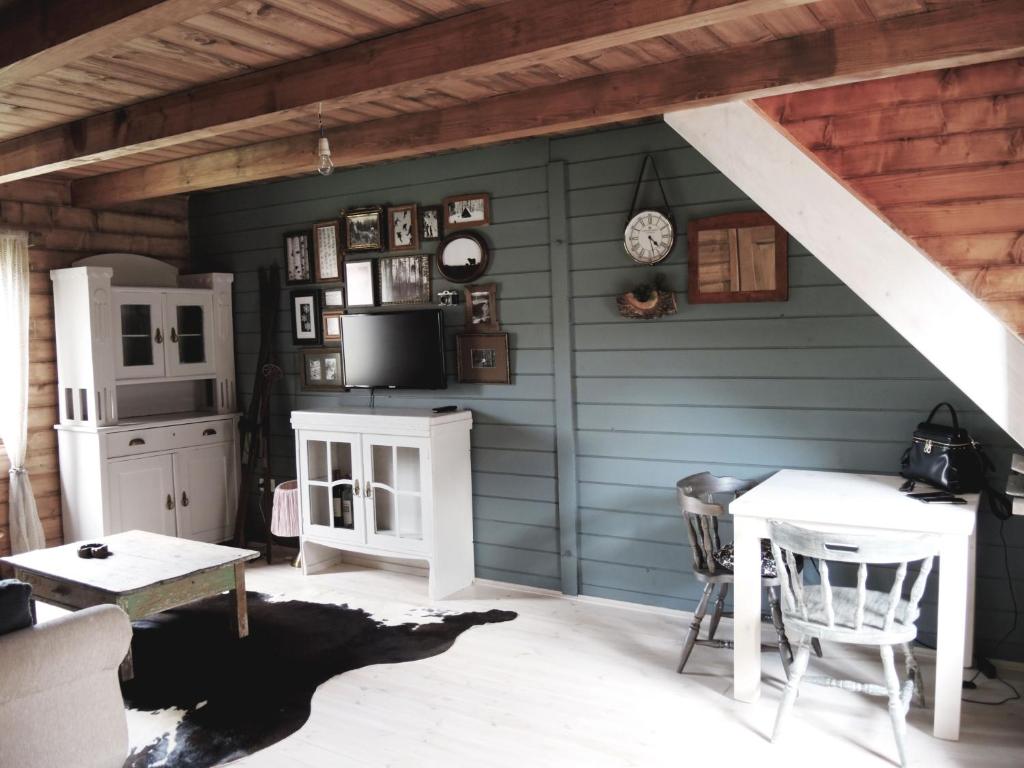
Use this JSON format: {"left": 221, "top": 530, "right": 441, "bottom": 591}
{"left": 782, "top": 585, "right": 918, "bottom": 645}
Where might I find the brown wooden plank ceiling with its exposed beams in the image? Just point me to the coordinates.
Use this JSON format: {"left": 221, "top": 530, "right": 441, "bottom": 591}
{"left": 0, "top": 0, "right": 1024, "bottom": 205}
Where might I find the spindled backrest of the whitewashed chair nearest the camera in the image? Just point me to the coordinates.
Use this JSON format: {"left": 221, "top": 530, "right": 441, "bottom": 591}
{"left": 769, "top": 520, "right": 939, "bottom": 632}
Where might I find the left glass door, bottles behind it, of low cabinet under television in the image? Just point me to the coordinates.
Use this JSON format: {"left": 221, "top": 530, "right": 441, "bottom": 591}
{"left": 299, "top": 432, "right": 364, "bottom": 543}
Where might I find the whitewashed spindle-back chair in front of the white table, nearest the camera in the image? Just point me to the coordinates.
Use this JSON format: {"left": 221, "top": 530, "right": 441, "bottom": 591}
{"left": 770, "top": 521, "right": 939, "bottom": 766}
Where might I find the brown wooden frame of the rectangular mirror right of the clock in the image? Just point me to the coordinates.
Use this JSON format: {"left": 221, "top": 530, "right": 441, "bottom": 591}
{"left": 686, "top": 211, "right": 790, "bottom": 304}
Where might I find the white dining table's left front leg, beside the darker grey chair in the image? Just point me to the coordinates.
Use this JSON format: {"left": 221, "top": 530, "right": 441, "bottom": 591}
{"left": 732, "top": 517, "right": 762, "bottom": 701}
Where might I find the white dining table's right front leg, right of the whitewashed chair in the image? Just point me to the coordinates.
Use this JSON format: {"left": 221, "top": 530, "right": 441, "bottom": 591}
{"left": 933, "top": 535, "right": 969, "bottom": 741}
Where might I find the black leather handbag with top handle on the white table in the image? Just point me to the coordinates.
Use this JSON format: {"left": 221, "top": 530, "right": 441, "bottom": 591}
{"left": 900, "top": 402, "right": 994, "bottom": 494}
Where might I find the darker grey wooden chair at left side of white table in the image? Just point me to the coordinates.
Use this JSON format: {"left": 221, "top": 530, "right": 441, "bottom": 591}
{"left": 676, "top": 472, "right": 821, "bottom": 676}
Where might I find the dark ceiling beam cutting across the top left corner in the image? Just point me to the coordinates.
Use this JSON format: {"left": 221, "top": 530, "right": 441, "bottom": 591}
{"left": 0, "top": 0, "right": 231, "bottom": 88}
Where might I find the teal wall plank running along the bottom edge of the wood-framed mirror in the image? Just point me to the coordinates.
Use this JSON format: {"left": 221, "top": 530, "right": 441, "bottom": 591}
{"left": 572, "top": 286, "right": 878, "bottom": 328}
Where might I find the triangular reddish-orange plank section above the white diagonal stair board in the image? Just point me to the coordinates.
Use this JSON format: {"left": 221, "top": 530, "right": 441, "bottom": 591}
{"left": 758, "top": 58, "right": 1024, "bottom": 338}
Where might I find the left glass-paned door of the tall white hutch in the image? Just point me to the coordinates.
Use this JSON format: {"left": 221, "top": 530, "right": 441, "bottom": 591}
{"left": 114, "top": 291, "right": 166, "bottom": 379}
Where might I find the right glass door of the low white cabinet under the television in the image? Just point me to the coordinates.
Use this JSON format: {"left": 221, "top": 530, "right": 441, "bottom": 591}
{"left": 362, "top": 437, "right": 426, "bottom": 550}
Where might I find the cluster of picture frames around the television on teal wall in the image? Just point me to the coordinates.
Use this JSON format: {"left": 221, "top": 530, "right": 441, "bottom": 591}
{"left": 285, "top": 193, "right": 511, "bottom": 392}
